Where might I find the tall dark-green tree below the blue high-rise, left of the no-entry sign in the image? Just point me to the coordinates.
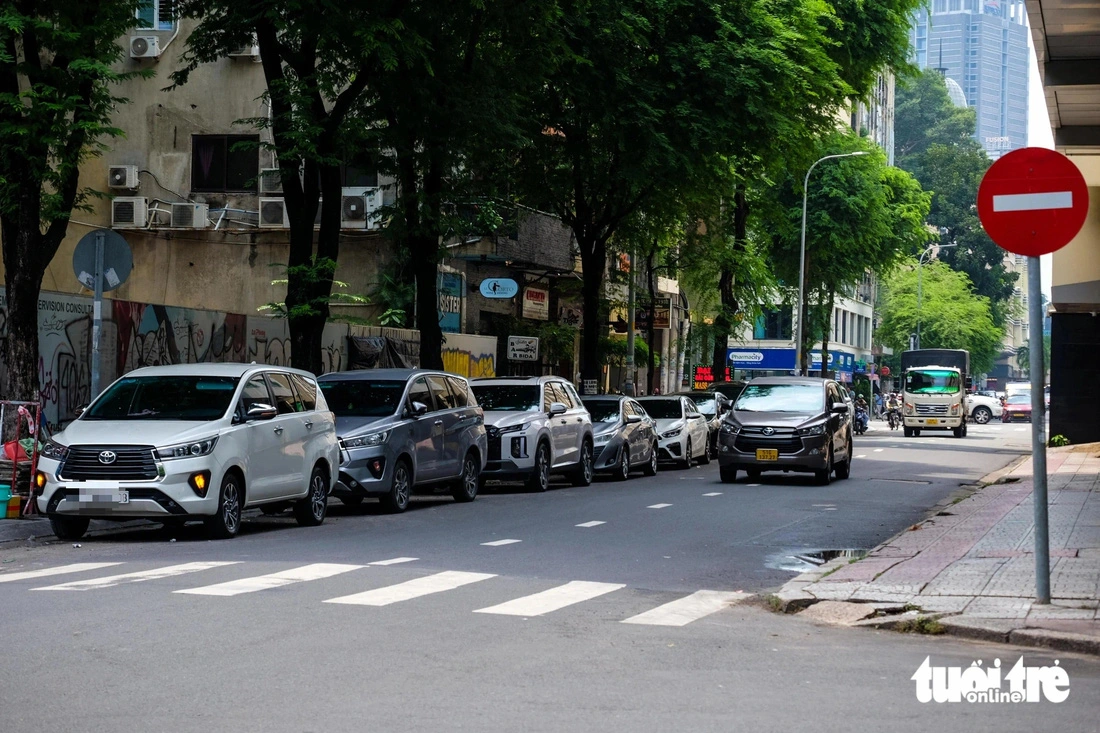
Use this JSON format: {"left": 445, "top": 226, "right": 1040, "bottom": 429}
{"left": 894, "top": 69, "right": 1018, "bottom": 316}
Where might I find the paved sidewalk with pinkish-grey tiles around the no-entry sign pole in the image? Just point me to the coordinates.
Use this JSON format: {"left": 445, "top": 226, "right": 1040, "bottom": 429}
{"left": 779, "top": 444, "right": 1100, "bottom": 654}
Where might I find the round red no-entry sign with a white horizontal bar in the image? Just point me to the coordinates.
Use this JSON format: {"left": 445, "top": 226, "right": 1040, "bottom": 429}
{"left": 978, "top": 147, "right": 1089, "bottom": 256}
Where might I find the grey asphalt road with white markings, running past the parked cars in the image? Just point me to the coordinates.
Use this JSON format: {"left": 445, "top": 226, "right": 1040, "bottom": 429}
{"left": 0, "top": 423, "right": 1100, "bottom": 732}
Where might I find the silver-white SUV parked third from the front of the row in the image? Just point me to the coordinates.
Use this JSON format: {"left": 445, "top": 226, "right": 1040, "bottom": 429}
{"left": 470, "top": 376, "right": 593, "bottom": 491}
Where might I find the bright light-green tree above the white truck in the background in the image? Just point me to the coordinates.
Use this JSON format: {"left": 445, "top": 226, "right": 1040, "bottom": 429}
{"left": 877, "top": 261, "right": 1003, "bottom": 374}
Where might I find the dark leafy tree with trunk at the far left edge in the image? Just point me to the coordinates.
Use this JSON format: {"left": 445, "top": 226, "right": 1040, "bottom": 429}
{"left": 0, "top": 0, "right": 141, "bottom": 400}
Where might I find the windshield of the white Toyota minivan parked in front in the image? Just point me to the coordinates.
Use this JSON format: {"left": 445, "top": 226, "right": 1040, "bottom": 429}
{"left": 80, "top": 375, "right": 239, "bottom": 422}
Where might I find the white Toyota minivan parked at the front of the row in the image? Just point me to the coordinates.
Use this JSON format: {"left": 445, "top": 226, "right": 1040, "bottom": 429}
{"left": 34, "top": 364, "right": 340, "bottom": 539}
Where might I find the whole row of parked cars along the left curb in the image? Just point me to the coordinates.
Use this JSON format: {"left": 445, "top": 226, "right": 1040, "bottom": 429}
{"left": 34, "top": 364, "right": 729, "bottom": 539}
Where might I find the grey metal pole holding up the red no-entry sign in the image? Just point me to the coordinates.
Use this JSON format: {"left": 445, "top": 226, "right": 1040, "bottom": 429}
{"left": 1027, "top": 256, "right": 1051, "bottom": 603}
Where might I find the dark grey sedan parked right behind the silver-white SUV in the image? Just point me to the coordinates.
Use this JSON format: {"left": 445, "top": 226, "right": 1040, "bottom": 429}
{"left": 582, "top": 395, "right": 657, "bottom": 481}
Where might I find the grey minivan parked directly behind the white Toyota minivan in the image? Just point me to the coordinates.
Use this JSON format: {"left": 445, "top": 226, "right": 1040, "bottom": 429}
{"left": 317, "top": 369, "right": 488, "bottom": 512}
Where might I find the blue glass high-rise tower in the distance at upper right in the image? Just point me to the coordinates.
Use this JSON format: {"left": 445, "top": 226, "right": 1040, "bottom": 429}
{"left": 911, "top": 0, "right": 1029, "bottom": 158}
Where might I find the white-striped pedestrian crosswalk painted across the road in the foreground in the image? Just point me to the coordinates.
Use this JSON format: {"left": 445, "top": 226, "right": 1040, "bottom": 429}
{"left": 0, "top": 557, "right": 748, "bottom": 626}
